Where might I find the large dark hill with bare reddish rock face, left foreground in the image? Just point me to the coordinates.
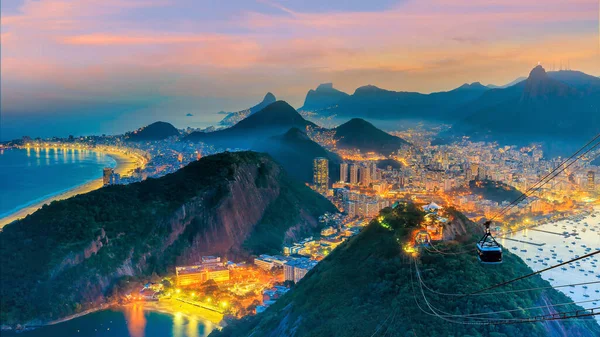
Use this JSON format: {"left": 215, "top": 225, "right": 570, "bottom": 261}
{"left": 0, "top": 152, "right": 336, "bottom": 327}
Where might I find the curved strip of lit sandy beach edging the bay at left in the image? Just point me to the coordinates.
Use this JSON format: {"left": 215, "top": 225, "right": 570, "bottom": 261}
{"left": 0, "top": 151, "right": 141, "bottom": 230}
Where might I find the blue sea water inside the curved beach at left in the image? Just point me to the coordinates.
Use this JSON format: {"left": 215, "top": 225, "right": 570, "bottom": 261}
{"left": 0, "top": 148, "right": 116, "bottom": 218}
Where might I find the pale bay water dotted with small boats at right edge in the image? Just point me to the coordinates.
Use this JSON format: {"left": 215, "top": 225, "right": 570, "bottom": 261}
{"left": 500, "top": 208, "right": 600, "bottom": 322}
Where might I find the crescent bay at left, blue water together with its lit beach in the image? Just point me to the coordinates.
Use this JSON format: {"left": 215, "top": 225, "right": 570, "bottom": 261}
{"left": 0, "top": 147, "right": 140, "bottom": 228}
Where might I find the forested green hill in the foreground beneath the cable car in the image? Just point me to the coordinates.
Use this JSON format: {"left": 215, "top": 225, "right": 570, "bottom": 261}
{"left": 211, "top": 205, "right": 600, "bottom": 337}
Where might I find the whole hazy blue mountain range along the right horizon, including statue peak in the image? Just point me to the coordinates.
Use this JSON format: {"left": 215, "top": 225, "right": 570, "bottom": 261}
{"left": 301, "top": 66, "right": 600, "bottom": 154}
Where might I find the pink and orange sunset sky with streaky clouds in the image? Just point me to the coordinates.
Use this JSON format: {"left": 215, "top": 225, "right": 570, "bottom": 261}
{"left": 0, "top": 0, "right": 600, "bottom": 140}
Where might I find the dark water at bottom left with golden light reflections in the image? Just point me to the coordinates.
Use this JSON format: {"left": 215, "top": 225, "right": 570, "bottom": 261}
{"left": 2, "top": 306, "right": 216, "bottom": 337}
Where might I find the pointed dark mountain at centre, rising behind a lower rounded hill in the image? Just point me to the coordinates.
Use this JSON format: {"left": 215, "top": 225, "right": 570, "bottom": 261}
{"left": 185, "top": 101, "right": 317, "bottom": 148}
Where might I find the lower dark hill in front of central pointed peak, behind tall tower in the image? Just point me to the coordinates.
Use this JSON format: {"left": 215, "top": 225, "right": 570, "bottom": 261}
{"left": 253, "top": 127, "right": 342, "bottom": 183}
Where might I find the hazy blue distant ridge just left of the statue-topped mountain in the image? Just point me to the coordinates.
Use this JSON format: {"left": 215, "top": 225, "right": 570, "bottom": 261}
{"left": 327, "top": 82, "right": 489, "bottom": 121}
